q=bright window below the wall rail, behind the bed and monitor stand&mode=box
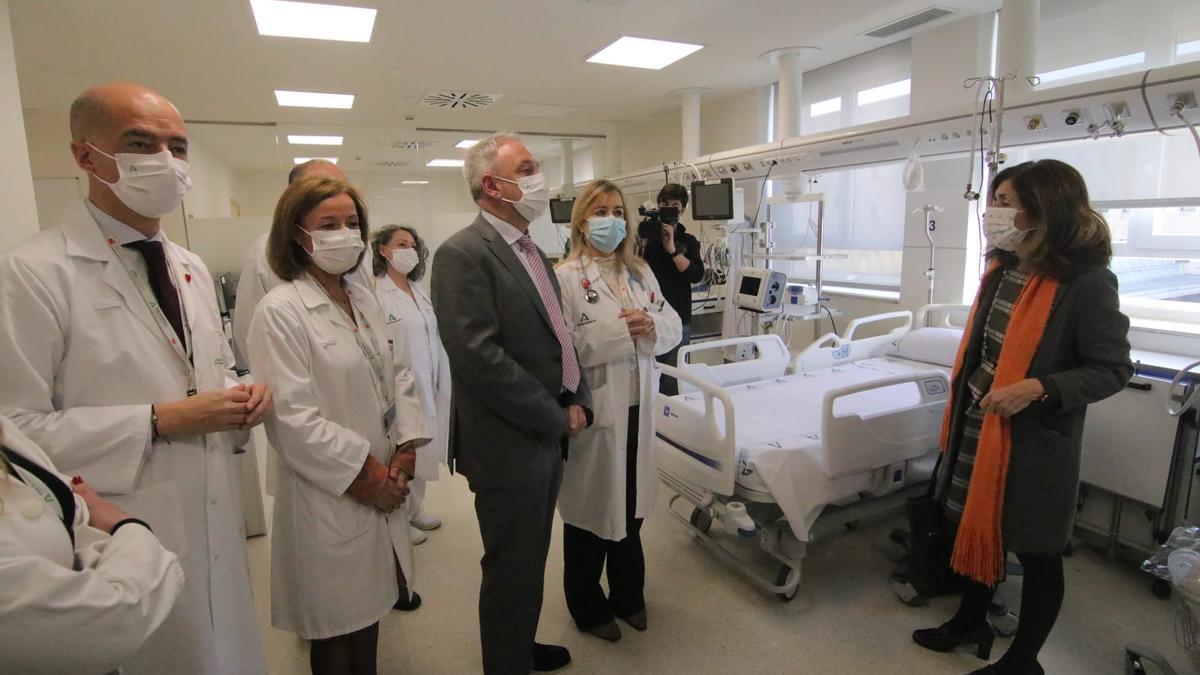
[769,163,907,292]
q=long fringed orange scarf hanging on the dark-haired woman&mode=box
[942,261,1058,586]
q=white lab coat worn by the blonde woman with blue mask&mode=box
[554,257,683,542]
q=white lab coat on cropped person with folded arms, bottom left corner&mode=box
[0,417,184,674]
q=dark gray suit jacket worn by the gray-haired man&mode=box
[431,215,592,488]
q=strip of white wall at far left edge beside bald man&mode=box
[0,0,37,251]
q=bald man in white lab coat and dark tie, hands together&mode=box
[0,84,271,674]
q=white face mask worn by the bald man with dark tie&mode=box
[88,143,192,217]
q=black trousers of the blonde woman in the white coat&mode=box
[563,406,646,631]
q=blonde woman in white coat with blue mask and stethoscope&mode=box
[554,180,683,640]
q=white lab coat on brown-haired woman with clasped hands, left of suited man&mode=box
[250,275,428,639]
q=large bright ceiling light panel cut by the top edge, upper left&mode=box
[250,0,376,42]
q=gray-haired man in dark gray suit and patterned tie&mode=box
[432,133,592,675]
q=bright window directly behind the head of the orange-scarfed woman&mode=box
[1009,133,1200,323]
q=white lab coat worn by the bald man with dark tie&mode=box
[0,201,266,675]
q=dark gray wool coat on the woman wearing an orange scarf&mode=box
[937,263,1133,555]
